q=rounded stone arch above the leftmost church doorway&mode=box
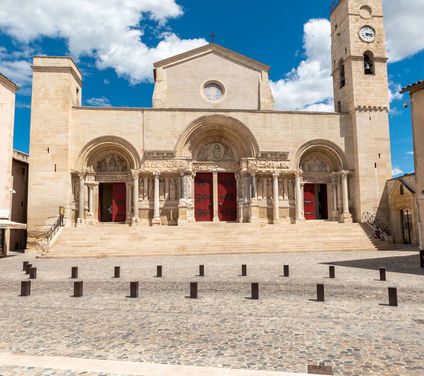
[76,136,141,172]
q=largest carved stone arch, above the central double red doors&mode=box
[175,115,259,161]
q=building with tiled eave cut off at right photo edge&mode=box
[402,81,424,250]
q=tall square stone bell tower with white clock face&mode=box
[331,0,392,223]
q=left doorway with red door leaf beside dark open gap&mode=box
[99,183,127,223]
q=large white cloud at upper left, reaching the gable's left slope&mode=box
[0,0,206,83]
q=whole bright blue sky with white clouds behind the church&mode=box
[0,0,424,173]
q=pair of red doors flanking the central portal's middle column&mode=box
[194,173,237,222]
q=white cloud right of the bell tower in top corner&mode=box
[383,0,424,63]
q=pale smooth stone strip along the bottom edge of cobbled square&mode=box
[0,352,307,376]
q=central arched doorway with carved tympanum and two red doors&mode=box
[176,115,258,222]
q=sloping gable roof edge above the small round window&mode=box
[153,43,271,72]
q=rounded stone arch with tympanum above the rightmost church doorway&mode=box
[296,140,348,173]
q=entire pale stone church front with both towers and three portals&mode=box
[28,0,391,238]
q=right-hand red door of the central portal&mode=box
[218,174,237,222]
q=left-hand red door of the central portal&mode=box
[194,173,213,222]
